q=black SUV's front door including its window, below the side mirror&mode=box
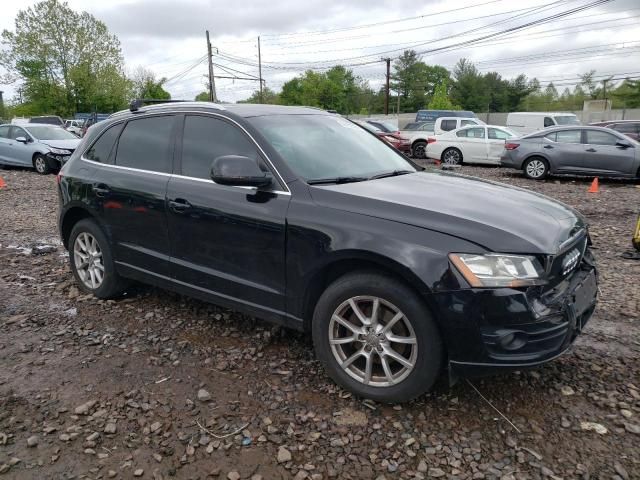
[167,114,290,316]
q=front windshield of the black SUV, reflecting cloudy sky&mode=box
[248,115,417,183]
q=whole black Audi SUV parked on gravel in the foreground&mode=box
[58,102,597,402]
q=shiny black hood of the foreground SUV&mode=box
[311,172,585,254]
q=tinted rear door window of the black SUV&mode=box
[116,116,174,173]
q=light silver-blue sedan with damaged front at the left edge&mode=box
[0,123,81,175]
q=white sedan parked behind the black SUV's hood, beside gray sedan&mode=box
[427,125,518,165]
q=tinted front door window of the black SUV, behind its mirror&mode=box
[182,115,258,179]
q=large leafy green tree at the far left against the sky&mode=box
[0,0,130,115]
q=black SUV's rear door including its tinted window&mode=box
[87,115,177,277]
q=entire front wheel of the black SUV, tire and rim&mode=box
[312,272,442,403]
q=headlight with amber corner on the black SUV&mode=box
[449,253,546,288]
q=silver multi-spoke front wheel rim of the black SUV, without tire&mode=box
[328,296,418,387]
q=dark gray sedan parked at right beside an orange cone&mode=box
[500,126,640,180]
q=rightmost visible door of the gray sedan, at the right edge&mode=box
[584,130,635,175]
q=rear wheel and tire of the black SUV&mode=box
[69,219,127,299]
